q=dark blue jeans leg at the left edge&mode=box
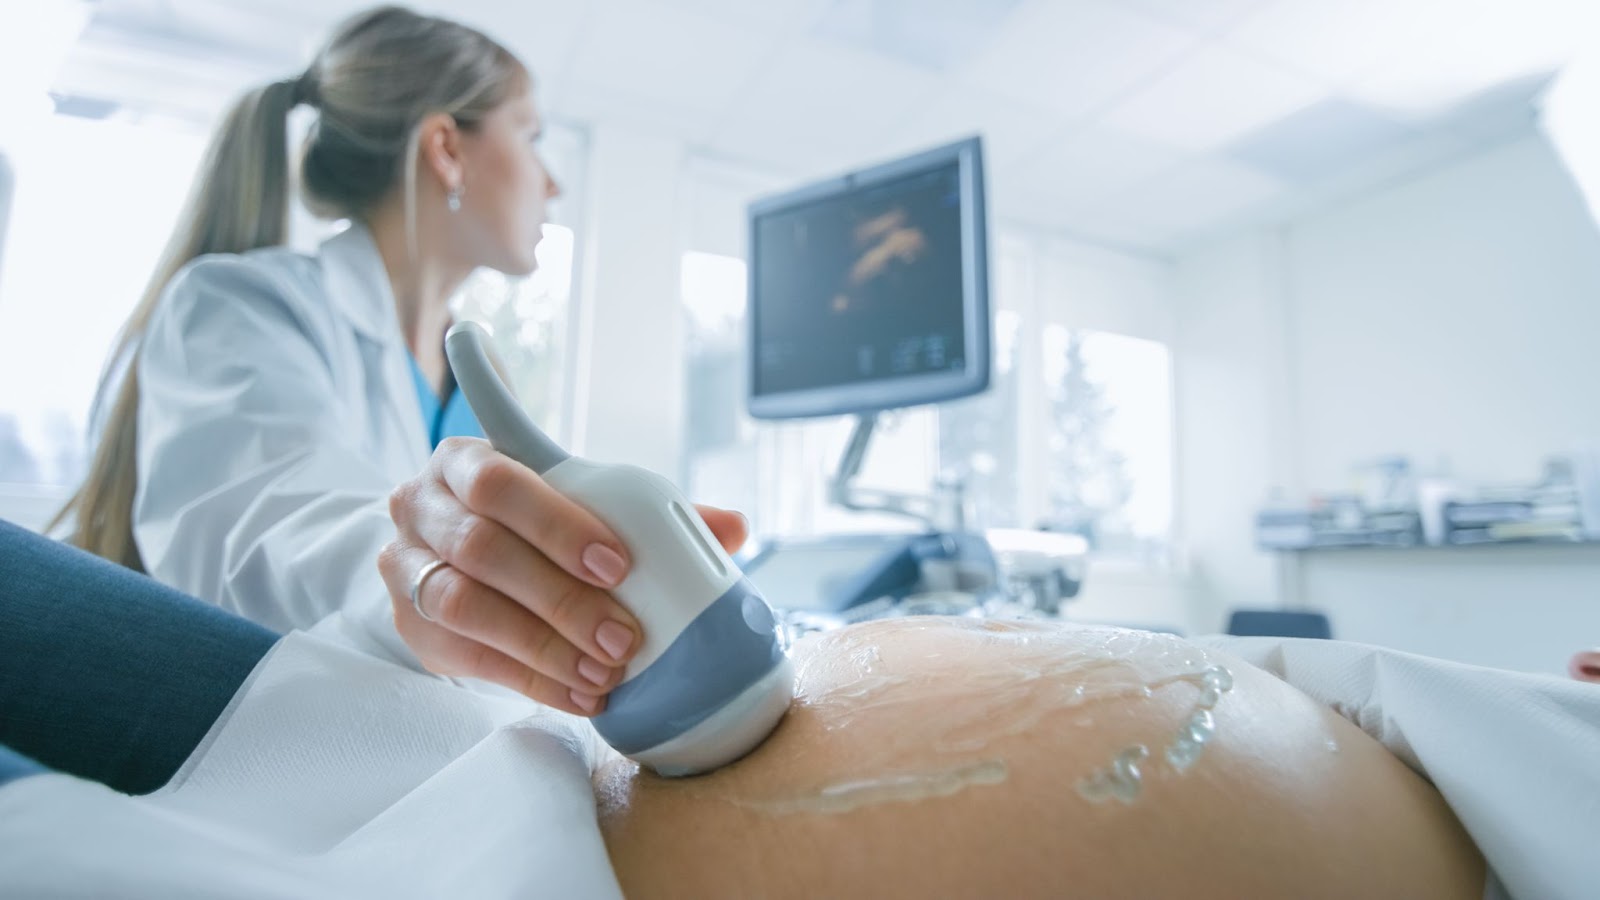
[0,520,278,794]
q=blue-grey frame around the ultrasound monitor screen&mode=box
[746,136,990,420]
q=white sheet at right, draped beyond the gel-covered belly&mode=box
[1197,636,1600,900]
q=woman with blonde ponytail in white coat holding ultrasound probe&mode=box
[62,6,744,714]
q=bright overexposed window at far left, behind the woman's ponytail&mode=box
[0,115,206,493]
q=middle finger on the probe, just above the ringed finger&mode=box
[402,482,640,666]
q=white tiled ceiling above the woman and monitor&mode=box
[43,0,1600,255]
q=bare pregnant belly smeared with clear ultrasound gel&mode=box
[595,618,1485,898]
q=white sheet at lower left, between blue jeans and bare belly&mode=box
[0,633,621,900]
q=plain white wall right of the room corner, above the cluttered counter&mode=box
[1290,138,1600,487]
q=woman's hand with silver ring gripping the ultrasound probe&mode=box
[378,437,747,716]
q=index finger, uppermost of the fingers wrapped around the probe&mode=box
[432,439,629,588]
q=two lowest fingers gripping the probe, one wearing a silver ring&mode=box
[378,543,622,714]
